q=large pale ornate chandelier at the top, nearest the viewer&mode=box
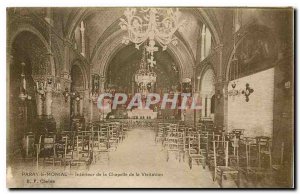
[119,8,185,60]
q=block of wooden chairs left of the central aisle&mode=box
[24,122,129,168]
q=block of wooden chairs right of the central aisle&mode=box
[155,123,283,187]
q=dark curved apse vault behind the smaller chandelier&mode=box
[106,44,180,88]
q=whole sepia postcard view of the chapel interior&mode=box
[7,7,294,188]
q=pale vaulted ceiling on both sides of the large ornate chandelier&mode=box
[61,8,218,61]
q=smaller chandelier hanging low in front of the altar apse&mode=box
[134,49,157,95]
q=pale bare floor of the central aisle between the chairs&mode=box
[60,128,218,188]
